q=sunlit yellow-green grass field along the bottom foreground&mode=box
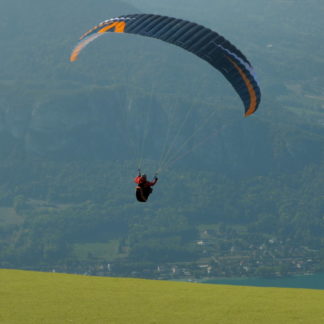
[0,269,324,324]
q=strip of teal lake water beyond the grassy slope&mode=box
[204,273,324,289]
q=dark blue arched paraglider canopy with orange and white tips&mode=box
[70,14,261,116]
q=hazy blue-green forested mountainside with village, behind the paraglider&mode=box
[0,0,324,278]
